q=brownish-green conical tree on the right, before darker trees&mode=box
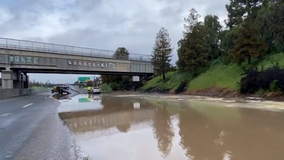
[230,19,267,64]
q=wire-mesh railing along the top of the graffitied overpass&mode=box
[0,37,151,62]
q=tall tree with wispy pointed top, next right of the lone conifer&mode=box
[176,9,209,76]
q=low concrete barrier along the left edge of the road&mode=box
[0,88,48,99]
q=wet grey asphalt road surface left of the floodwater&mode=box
[0,93,78,160]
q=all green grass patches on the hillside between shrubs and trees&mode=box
[142,53,284,90]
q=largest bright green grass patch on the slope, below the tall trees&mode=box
[188,64,243,89]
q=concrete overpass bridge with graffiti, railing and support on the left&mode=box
[0,38,153,89]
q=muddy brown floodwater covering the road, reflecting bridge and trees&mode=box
[58,95,284,160]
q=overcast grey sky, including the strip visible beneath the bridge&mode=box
[0,0,229,83]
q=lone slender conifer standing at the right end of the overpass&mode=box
[151,27,172,80]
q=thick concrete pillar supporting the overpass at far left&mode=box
[1,70,19,89]
